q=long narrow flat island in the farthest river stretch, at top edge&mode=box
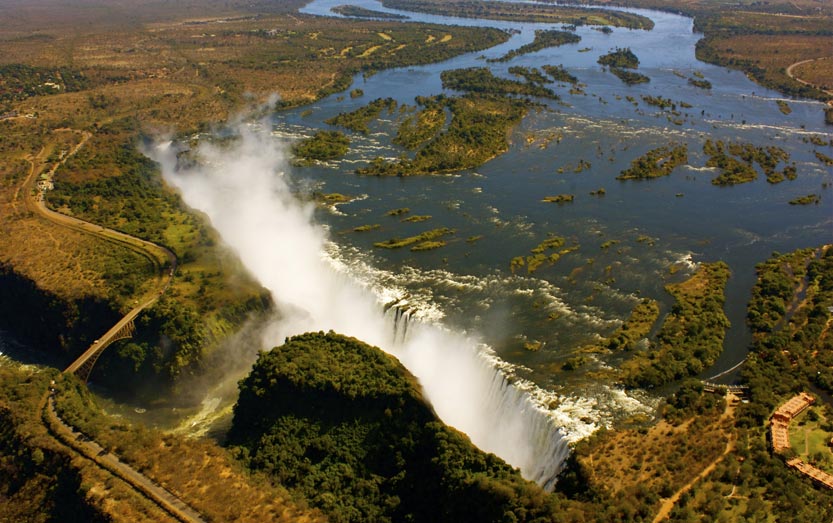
[382,0,654,29]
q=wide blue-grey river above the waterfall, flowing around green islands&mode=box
[30,0,833,450]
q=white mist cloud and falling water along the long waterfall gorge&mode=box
[150,121,569,488]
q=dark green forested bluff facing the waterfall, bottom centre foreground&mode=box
[228,332,558,522]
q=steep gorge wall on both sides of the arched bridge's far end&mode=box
[0,263,272,399]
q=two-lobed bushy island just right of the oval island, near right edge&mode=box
[703,139,797,185]
